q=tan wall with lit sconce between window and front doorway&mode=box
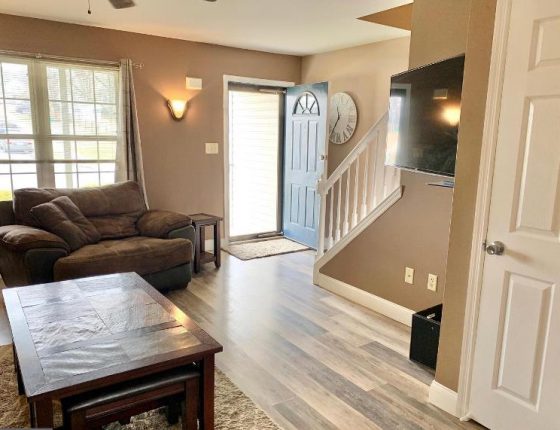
[0,15,301,215]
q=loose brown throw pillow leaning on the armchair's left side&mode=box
[31,196,101,251]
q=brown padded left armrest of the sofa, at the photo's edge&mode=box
[0,225,70,252]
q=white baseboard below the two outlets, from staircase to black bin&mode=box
[315,273,414,327]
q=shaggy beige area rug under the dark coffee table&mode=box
[0,346,278,430]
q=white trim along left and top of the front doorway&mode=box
[223,75,295,245]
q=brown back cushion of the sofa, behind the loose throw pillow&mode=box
[14,181,147,239]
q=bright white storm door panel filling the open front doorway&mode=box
[228,85,284,240]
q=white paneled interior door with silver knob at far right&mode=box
[470,0,560,430]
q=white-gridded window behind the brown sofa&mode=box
[0,57,124,200]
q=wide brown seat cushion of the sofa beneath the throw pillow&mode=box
[54,236,192,281]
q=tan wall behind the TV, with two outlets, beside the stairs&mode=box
[321,0,470,310]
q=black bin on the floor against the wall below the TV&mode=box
[409,305,443,370]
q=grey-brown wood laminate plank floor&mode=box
[0,251,481,430]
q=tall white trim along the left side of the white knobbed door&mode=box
[457,0,513,420]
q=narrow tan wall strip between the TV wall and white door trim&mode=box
[436,0,496,390]
